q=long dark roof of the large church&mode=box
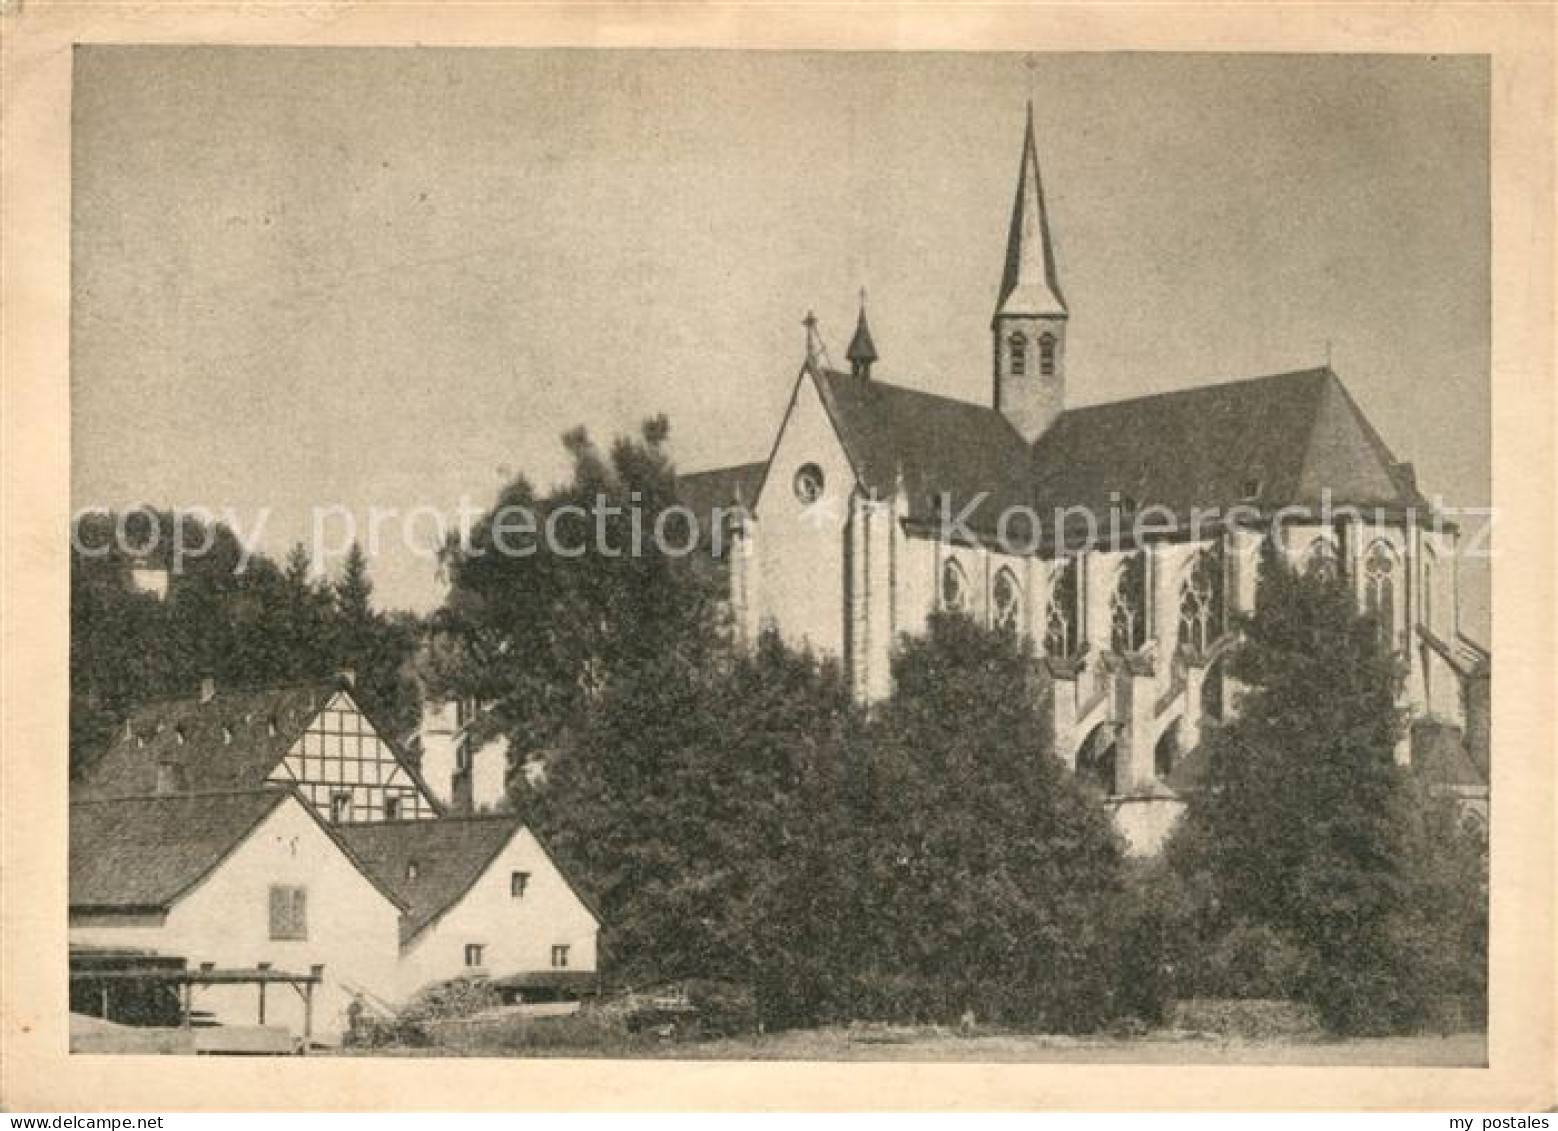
[701,368,1429,541]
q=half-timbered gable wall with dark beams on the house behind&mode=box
[270,690,438,824]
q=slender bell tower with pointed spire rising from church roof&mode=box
[991,101,1067,444]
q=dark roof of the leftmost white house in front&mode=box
[70,788,291,911]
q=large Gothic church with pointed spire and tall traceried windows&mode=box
[682,106,1489,854]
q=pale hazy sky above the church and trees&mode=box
[72,47,1491,639]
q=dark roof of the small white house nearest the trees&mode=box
[337,816,600,943]
